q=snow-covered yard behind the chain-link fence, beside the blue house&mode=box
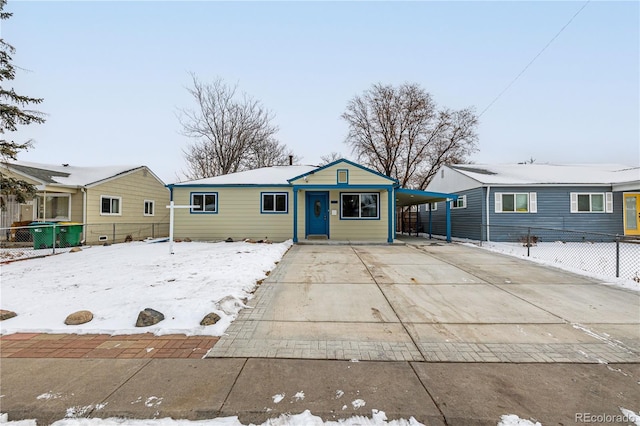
[474,241,640,291]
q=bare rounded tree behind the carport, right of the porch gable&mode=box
[342,83,478,189]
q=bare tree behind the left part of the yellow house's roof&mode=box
[178,74,291,179]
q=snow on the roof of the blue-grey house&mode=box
[450,164,640,185]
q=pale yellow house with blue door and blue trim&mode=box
[168,160,455,243]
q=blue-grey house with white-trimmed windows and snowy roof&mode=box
[421,164,640,241]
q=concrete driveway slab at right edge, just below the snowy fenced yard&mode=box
[498,284,640,324]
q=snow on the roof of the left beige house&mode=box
[7,161,144,186]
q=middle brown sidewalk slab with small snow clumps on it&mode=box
[221,359,444,425]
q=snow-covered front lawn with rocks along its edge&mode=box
[0,241,292,336]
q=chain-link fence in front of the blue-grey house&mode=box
[480,225,640,282]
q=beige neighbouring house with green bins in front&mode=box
[0,161,169,243]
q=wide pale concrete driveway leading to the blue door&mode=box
[208,240,640,363]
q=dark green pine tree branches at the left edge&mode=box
[0,0,45,203]
